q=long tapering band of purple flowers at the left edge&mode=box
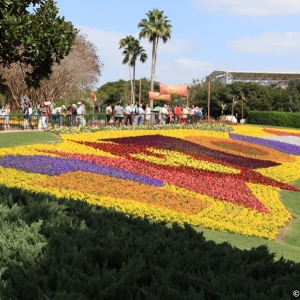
[0,155,164,186]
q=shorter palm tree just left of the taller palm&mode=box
[119,35,148,103]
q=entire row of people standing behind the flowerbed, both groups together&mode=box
[0,101,203,130]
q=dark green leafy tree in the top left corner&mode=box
[0,0,77,87]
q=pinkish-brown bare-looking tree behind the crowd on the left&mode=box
[0,34,103,108]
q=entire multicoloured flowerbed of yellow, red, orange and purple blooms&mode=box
[0,125,300,239]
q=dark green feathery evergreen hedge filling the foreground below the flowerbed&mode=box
[0,186,300,300]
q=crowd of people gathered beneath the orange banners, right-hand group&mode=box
[105,102,203,125]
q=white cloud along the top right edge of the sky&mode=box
[192,0,300,16]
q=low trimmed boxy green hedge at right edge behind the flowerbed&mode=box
[247,111,300,128]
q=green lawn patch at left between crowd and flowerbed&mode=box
[0,131,62,148]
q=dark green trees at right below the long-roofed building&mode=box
[189,80,300,119]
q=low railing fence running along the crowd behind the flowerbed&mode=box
[0,112,202,130]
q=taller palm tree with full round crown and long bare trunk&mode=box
[138,8,172,108]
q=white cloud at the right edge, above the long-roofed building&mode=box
[226,32,300,53]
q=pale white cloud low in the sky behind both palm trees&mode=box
[75,26,199,84]
